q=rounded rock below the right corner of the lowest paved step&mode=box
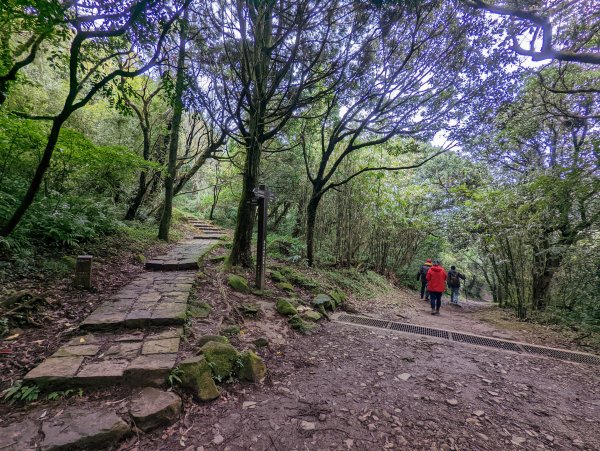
[129,387,181,432]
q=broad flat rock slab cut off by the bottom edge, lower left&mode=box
[41,408,131,451]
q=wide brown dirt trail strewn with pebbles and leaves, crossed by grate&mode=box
[131,284,600,451]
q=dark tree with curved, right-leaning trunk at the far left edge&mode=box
[0,0,185,236]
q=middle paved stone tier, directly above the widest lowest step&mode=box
[80,271,196,330]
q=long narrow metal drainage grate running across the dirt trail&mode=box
[337,313,600,365]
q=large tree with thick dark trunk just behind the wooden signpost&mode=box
[199,0,348,266]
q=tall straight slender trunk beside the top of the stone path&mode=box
[158,15,188,241]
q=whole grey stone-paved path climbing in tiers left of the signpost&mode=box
[25,231,217,389]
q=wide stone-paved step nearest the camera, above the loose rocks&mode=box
[24,327,183,390]
